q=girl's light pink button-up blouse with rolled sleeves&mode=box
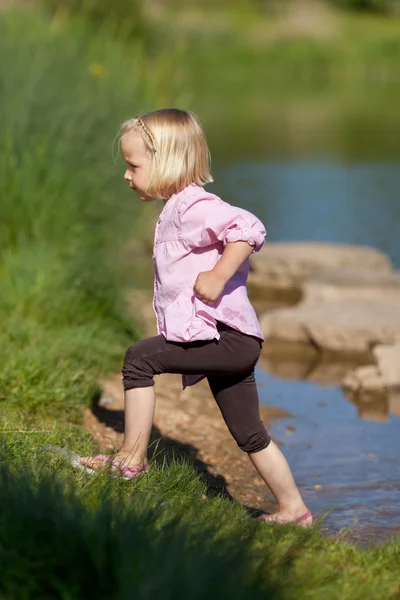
[153,185,266,389]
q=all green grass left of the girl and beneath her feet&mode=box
[0,5,400,600]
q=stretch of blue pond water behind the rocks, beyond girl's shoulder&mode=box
[216,161,400,268]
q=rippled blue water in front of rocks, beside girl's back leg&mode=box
[257,361,400,544]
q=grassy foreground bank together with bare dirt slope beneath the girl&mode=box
[0,290,400,600]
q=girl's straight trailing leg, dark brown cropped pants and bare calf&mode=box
[208,370,312,525]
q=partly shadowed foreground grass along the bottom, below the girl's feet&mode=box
[0,431,400,600]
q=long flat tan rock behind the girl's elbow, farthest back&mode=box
[248,242,392,290]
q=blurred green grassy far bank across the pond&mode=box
[141,2,400,162]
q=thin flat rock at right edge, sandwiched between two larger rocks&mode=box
[302,267,400,304]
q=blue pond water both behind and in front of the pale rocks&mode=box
[209,107,400,544]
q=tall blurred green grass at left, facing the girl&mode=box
[0,12,167,421]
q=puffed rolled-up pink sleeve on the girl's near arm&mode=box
[180,198,266,253]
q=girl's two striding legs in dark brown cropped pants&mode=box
[81,330,310,510]
